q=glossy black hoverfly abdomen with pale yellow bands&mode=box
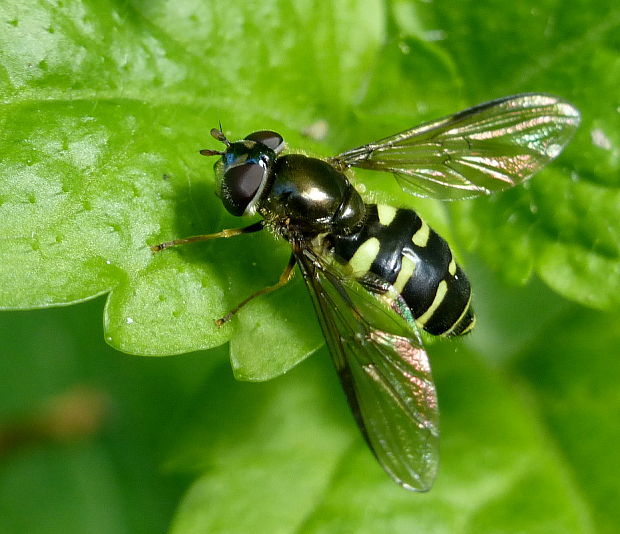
[329,204,475,336]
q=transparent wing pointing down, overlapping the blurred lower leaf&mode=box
[297,245,439,491]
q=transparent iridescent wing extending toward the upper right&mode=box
[330,93,580,200]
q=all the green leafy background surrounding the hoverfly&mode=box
[0,0,620,534]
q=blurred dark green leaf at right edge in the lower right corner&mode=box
[514,310,620,532]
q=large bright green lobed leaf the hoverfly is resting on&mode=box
[0,0,620,368]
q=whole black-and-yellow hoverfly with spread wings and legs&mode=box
[152,93,579,491]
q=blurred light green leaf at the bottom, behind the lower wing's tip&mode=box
[172,344,589,534]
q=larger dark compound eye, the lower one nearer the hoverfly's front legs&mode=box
[221,163,267,217]
